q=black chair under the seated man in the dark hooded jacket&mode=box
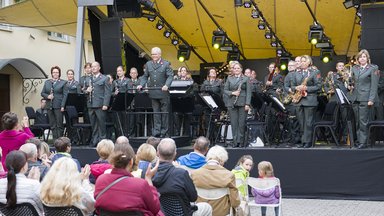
[160,193,192,216]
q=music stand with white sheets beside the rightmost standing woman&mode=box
[336,88,356,148]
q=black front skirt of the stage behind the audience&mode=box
[72,142,384,201]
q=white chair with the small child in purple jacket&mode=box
[247,177,282,216]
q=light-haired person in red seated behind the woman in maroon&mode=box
[89,139,115,184]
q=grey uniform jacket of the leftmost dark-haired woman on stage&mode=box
[41,79,67,109]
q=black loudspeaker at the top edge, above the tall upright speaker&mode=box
[108,0,142,18]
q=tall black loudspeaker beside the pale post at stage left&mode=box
[100,18,122,74]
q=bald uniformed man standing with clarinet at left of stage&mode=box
[86,62,112,146]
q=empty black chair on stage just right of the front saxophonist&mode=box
[312,101,340,146]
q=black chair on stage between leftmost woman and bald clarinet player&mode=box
[65,106,92,145]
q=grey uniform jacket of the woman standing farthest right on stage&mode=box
[352,64,380,102]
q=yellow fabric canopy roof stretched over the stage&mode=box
[0,0,360,70]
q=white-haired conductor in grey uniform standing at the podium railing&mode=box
[137,47,173,137]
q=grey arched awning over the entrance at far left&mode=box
[0,58,48,79]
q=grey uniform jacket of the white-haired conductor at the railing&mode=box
[140,59,173,99]
